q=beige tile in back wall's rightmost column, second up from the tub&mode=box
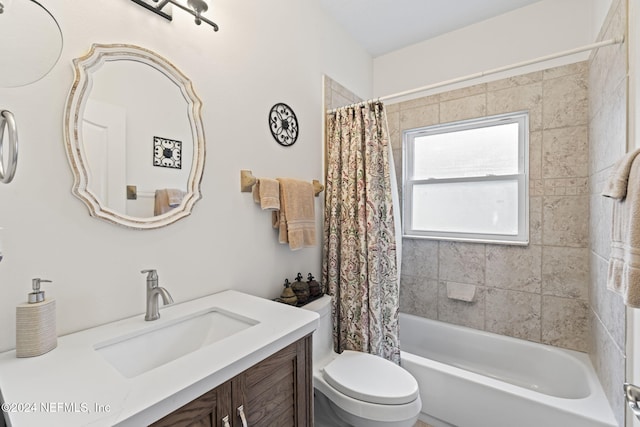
[542,246,589,300]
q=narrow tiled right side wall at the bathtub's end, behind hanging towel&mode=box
[589,0,627,426]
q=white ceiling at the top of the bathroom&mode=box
[320,0,540,57]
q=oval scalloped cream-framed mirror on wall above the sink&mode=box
[62,44,205,228]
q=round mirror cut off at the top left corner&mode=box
[0,0,62,87]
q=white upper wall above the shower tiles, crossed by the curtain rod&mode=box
[373,0,611,102]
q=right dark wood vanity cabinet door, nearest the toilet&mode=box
[232,336,313,427]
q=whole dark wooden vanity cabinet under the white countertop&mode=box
[151,335,313,427]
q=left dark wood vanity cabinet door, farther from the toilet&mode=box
[151,381,233,427]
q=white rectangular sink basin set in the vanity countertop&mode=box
[94,308,259,378]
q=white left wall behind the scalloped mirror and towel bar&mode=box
[0,0,373,350]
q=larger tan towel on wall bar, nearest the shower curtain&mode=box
[272,178,316,251]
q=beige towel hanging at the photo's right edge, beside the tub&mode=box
[603,151,640,308]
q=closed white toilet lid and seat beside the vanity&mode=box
[323,350,418,405]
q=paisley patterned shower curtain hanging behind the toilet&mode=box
[322,102,400,363]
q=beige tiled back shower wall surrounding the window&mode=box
[387,62,589,351]
